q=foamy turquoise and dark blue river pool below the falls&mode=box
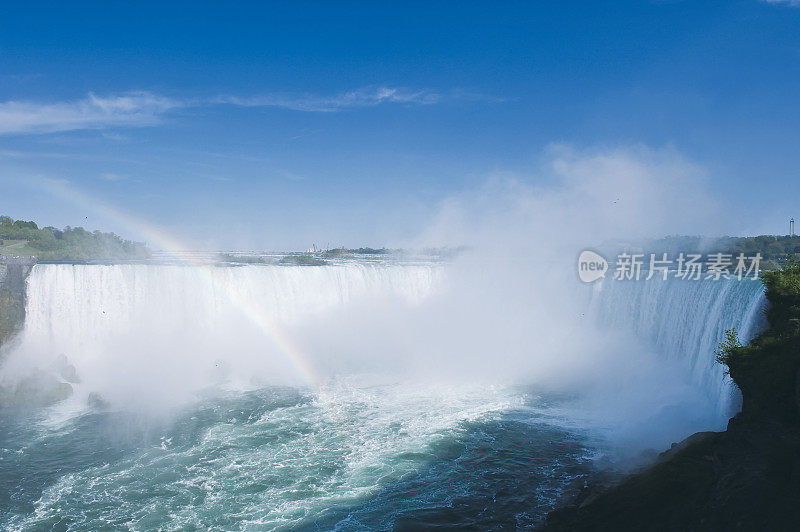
[0,385,594,530]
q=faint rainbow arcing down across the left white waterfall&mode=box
[32,179,323,395]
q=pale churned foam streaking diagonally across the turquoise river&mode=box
[11,381,523,529]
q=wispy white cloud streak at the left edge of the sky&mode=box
[0,92,182,134]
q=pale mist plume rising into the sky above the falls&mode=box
[410,145,723,255]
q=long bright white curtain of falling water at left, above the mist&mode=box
[25,263,442,338]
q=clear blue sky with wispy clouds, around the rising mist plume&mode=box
[0,0,800,249]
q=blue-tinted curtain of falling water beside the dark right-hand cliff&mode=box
[592,279,765,422]
